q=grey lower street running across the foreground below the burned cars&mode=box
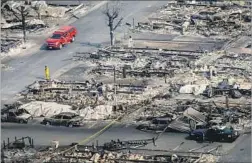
[1,123,251,163]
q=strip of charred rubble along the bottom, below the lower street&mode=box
[1,137,218,163]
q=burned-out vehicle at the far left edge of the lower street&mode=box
[1,109,32,123]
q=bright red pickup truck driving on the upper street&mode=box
[46,26,77,49]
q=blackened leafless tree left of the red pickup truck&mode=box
[11,6,29,42]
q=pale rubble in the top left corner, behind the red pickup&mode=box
[1,1,88,36]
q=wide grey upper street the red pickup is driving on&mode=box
[1,1,166,103]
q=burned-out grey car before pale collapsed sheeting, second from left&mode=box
[41,112,83,127]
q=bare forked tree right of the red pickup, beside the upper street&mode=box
[103,3,123,46]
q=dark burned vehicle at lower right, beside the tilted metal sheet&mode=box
[189,126,240,142]
